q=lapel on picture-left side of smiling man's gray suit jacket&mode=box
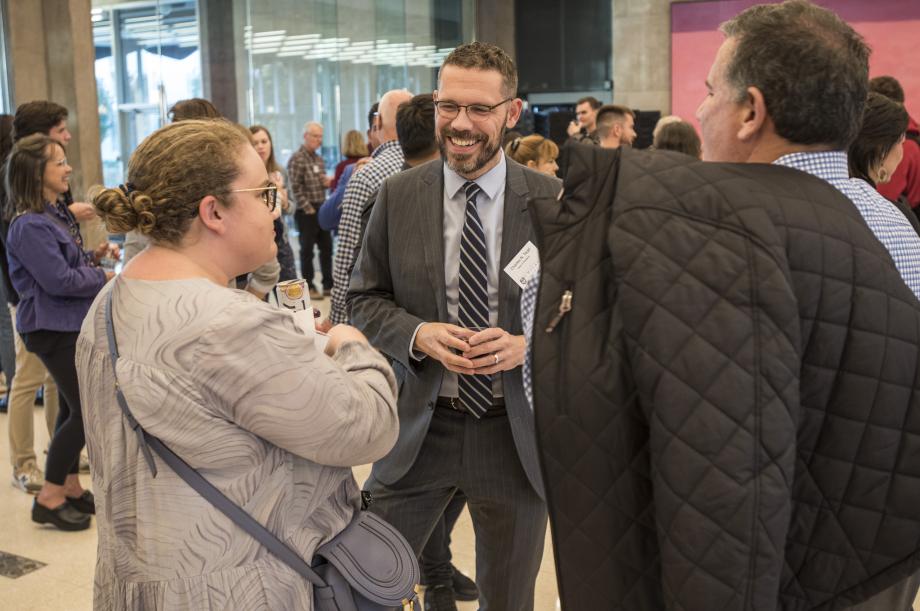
[418,162,447,322]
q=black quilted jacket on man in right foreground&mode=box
[532,147,920,611]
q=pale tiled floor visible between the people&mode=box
[0,286,558,611]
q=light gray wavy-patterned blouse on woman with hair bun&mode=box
[77,278,399,610]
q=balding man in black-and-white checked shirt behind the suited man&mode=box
[329,89,412,325]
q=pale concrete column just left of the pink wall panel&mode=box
[612,0,671,114]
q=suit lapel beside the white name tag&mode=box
[498,159,531,333]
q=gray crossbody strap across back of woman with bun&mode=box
[105,286,326,588]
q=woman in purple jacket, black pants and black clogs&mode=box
[5,134,113,530]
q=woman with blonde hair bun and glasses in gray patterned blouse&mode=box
[85,121,398,610]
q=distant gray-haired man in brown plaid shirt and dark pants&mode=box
[288,121,332,299]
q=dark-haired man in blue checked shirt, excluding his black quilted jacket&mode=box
[697,2,920,611]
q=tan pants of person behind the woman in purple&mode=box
[7,306,58,470]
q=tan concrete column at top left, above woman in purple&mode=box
[7,0,105,245]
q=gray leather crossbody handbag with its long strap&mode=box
[105,287,419,611]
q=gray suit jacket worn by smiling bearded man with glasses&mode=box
[347,159,562,498]
